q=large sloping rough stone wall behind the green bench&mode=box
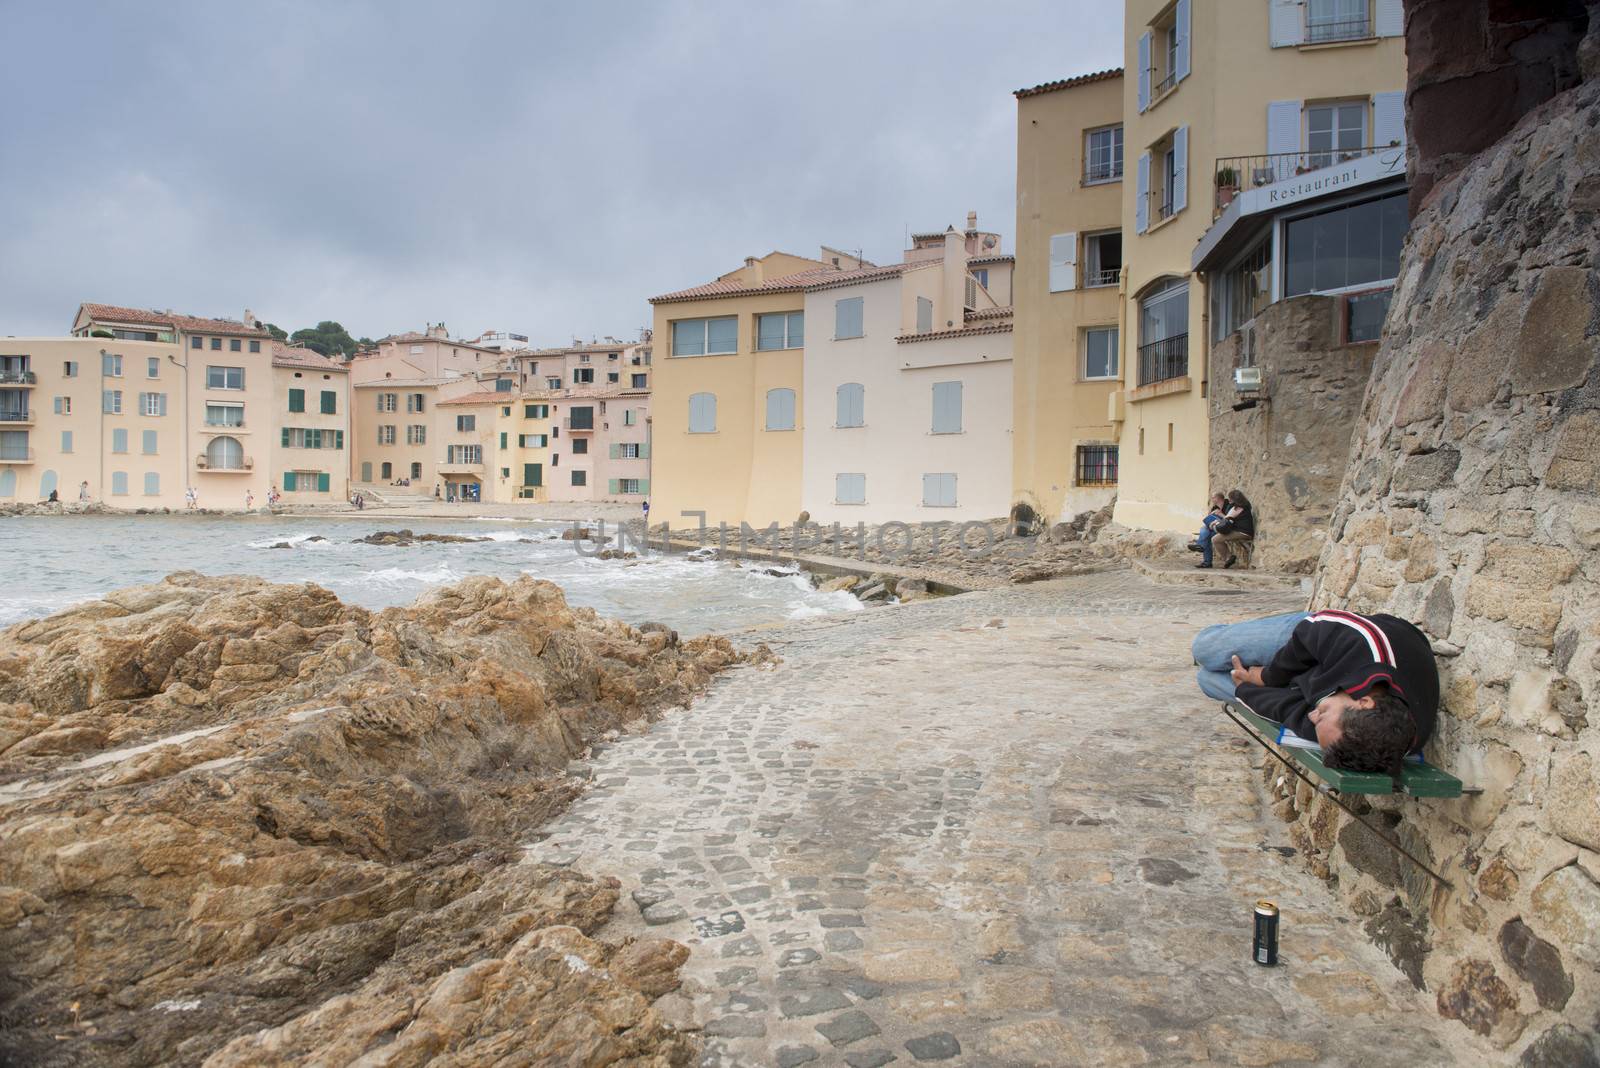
[1280,3,1600,1065]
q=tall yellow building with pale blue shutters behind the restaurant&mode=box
[1107,0,1405,531]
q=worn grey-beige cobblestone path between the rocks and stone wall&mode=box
[530,571,1454,1068]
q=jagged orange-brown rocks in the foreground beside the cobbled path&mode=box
[0,572,760,1065]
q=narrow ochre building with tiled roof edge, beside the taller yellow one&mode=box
[1011,70,1123,521]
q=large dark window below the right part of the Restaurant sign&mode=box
[1283,193,1406,297]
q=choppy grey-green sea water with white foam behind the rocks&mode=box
[0,515,861,635]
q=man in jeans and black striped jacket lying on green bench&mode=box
[1192,609,1438,775]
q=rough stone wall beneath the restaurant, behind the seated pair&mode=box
[1206,296,1378,574]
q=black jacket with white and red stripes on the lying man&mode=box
[1237,609,1438,753]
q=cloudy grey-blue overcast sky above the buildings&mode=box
[0,0,1122,344]
